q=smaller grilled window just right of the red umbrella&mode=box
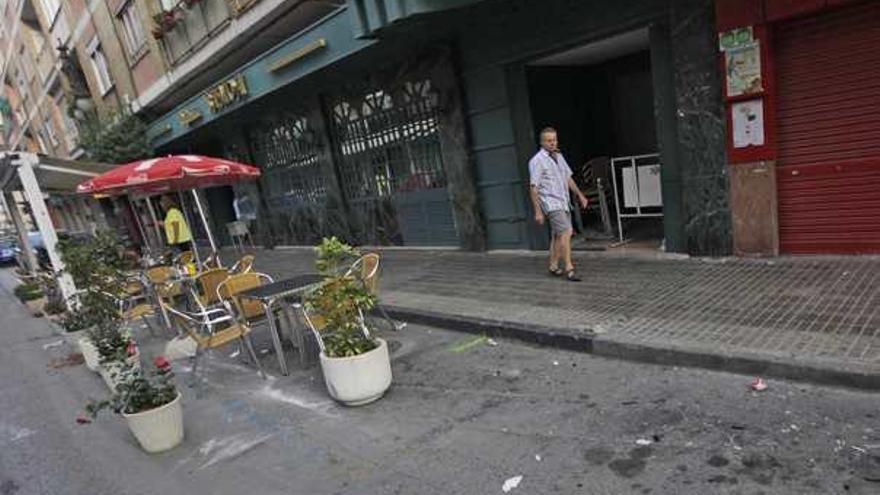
[251,114,327,209]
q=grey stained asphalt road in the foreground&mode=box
[0,272,880,495]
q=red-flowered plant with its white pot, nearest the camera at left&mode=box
[86,356,183,454]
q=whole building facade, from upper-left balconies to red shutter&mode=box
[0,0,880,255]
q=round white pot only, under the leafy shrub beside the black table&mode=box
[321,339,391,406]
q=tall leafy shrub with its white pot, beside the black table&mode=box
[305,237,392,406]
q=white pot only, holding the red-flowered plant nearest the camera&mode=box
[122,392,183,454]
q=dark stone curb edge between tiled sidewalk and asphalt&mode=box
[382,305,880,391]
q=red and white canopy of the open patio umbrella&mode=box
[76,155,260,194]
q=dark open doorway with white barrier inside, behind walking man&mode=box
[526,29,663,250]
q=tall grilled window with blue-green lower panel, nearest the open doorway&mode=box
[331,79,458,245]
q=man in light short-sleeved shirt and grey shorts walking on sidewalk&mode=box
[529,127,589,282]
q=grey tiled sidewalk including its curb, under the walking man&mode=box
[244,249,880,389]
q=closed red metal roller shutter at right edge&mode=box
[775,1,880,254]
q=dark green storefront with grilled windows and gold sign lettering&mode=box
[151,0,730,254]
